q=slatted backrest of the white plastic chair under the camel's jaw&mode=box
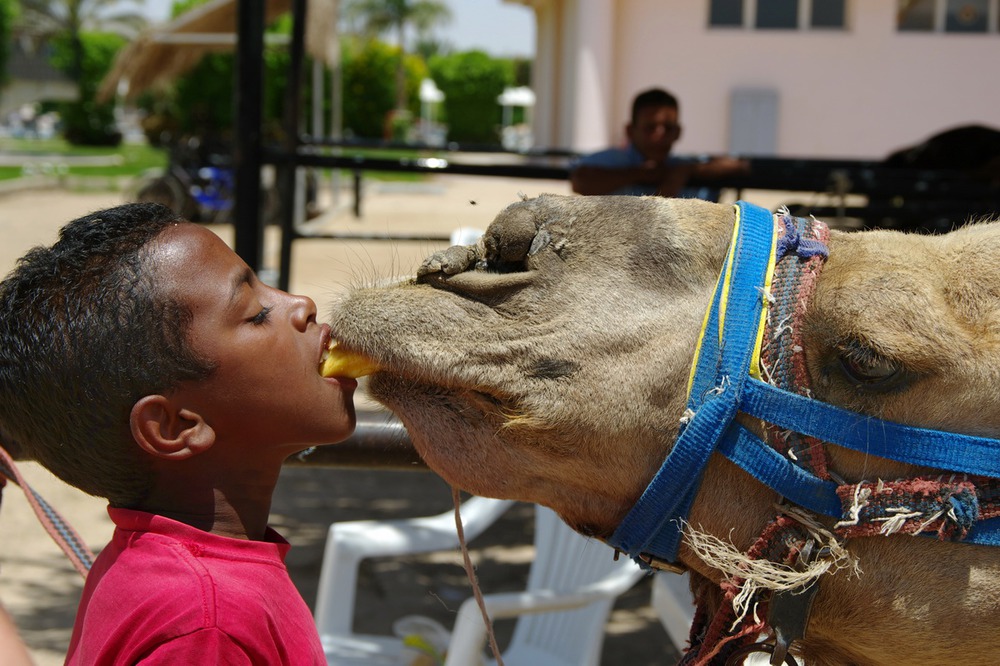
[503,505,644,666]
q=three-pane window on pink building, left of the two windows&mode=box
[708,0,845,30]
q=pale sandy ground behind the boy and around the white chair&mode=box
[0,176,712,666]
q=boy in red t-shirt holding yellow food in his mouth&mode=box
[0,204,357,666]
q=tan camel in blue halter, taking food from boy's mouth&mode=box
[331,195,1000,665]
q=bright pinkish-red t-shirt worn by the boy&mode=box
[66,508,326,666]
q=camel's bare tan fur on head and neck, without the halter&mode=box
[331,196,1000,663]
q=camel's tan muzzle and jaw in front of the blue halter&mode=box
[331,197,732,534]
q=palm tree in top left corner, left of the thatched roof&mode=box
[20,0,146,80]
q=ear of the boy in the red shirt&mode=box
[129,395,215,460]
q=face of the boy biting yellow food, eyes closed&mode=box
[154,224,357,453]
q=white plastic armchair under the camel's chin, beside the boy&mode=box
[316,497,643,666]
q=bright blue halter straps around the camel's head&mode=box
[608,201,1000,566]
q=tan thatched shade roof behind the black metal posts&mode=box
[98,0,338,100]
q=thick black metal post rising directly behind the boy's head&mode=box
[233,0,264,271]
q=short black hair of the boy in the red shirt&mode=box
[0,204,218,507]
